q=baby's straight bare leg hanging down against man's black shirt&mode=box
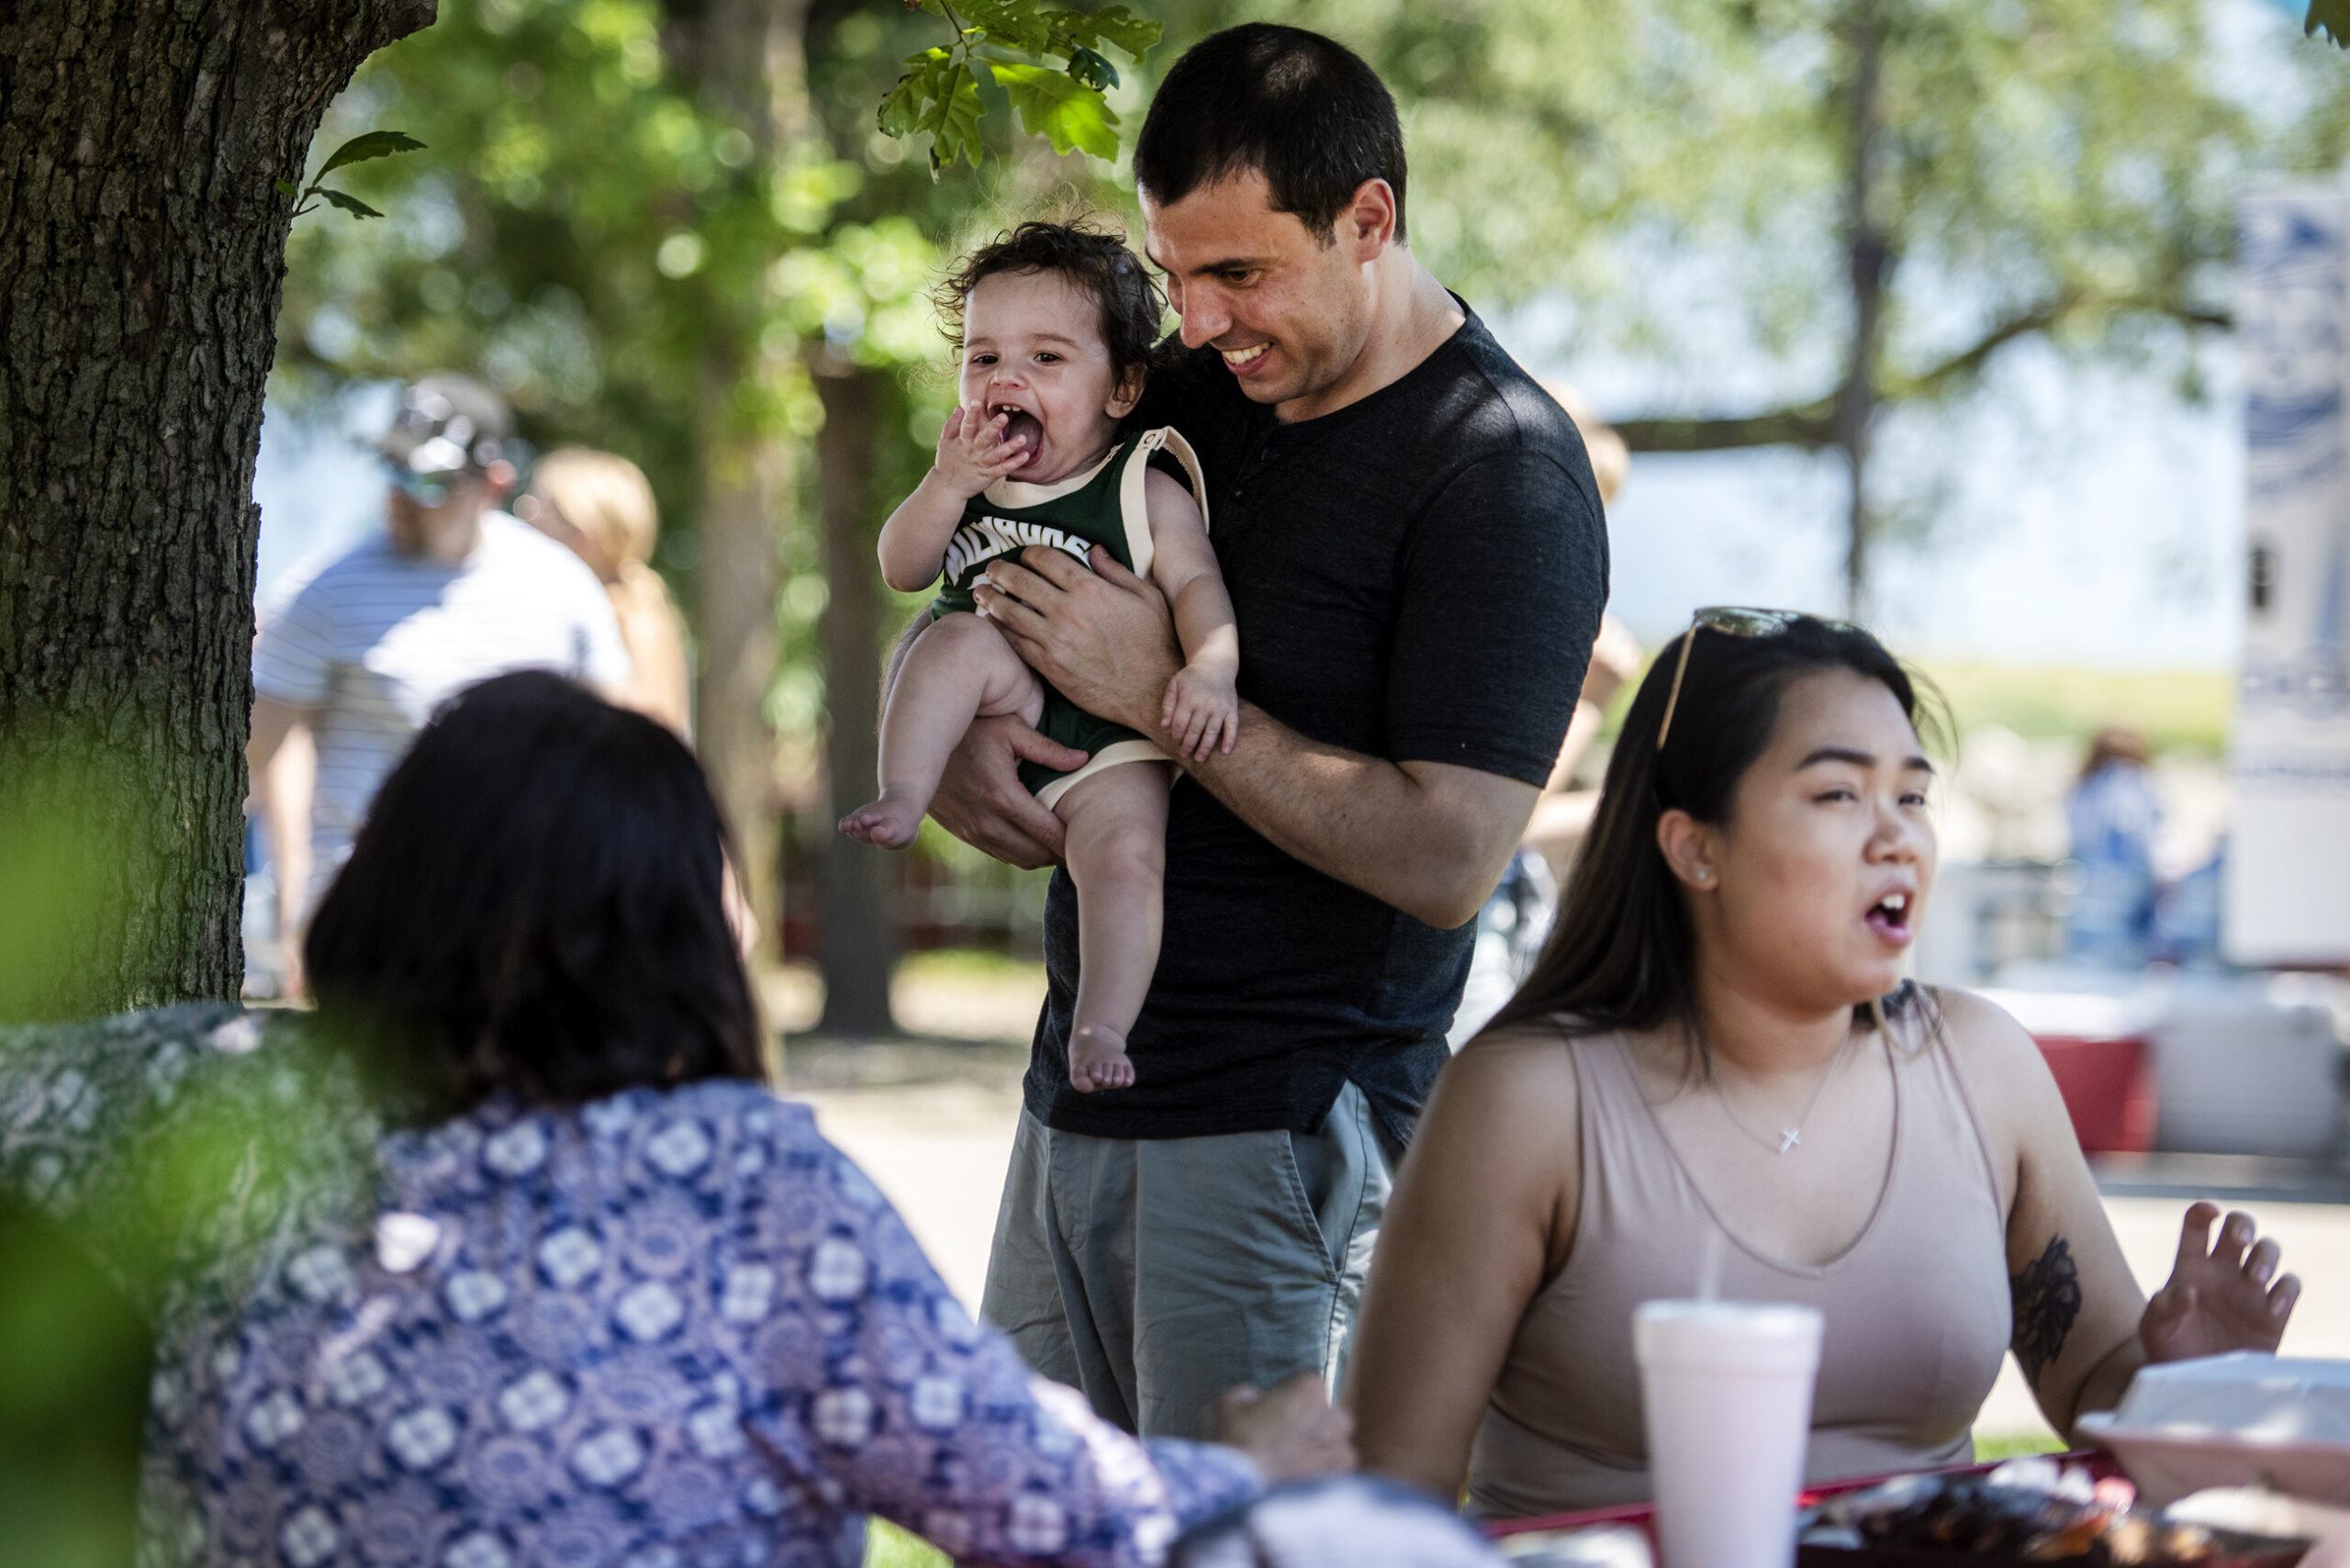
[1058,762,1168,1093]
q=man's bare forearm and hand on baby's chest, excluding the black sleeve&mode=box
[977,548,1537,928]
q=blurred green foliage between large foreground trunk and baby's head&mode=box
[273,0,1135,790]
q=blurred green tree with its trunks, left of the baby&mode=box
[277,0,1165,1036]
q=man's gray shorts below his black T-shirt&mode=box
[982,1083,1401,1437]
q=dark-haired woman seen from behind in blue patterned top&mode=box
[0,675,1348,1568]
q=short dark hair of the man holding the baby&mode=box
[1135,21,1403,244]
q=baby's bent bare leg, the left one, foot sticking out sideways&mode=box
[841,613,1044,848]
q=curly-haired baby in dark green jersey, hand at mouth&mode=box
[841,223,1241,1093]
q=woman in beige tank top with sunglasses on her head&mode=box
[1347,611,2300,1517]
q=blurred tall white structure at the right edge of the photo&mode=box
[2221,188,2350,964]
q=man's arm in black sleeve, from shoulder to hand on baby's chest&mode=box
[978,434,1607,928]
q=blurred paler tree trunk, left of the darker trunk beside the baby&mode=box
[663,0,809,958]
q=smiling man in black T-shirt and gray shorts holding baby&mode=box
[907,24,1607,1437]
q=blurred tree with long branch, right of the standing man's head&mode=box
[1249,0,2343,611]
